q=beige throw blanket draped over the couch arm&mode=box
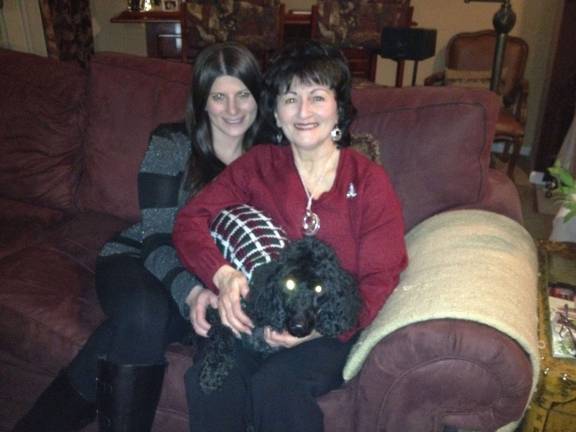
[344,210,539,432]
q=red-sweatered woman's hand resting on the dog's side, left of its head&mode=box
[213,265,254,336]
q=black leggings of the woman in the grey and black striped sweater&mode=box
[68,255,191,401]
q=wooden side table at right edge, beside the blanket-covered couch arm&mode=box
[522,241,576,432]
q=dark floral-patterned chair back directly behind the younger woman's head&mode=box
[180,0,284,66]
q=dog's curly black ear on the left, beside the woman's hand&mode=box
[245,261,286,330]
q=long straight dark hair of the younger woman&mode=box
[185,42,262,196]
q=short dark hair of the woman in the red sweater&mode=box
[259,40,356,147]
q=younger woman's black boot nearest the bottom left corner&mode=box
[12,370,96,432]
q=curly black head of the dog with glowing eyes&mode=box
[247,237,361,337]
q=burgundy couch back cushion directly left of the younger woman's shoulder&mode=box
[78,53,191,221]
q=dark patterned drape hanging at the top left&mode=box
[39,0,94,65]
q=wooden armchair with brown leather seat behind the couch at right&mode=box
[424,30,529,178]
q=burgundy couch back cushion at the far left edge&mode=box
[0,49,86,210]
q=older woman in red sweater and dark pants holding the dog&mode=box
[173,41,406,432]
